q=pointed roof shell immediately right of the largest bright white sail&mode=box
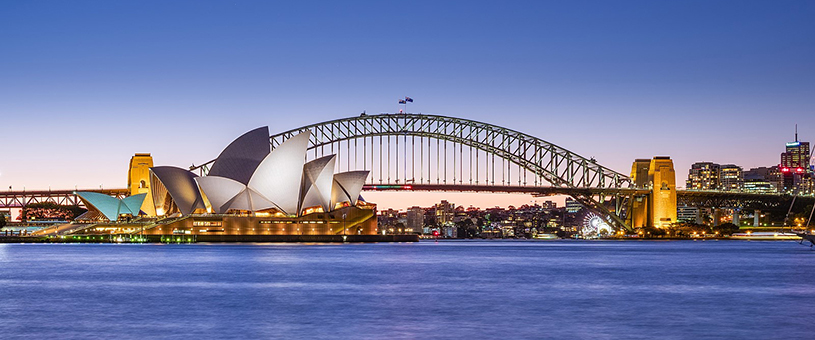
[298,155,337,212]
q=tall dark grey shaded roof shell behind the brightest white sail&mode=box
[208,126,270,184]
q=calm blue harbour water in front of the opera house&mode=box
[0,241,815,339]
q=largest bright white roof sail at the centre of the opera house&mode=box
[249,131,311,215]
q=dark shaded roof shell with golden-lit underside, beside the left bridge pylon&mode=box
[150,166,206,215]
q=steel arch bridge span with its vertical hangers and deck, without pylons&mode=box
[191,114,641,227]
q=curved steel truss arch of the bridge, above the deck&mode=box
[270,114,631,188]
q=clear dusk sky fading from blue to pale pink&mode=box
[0,1,815,208]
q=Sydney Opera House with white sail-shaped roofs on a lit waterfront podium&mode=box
[60,127,386,241]
